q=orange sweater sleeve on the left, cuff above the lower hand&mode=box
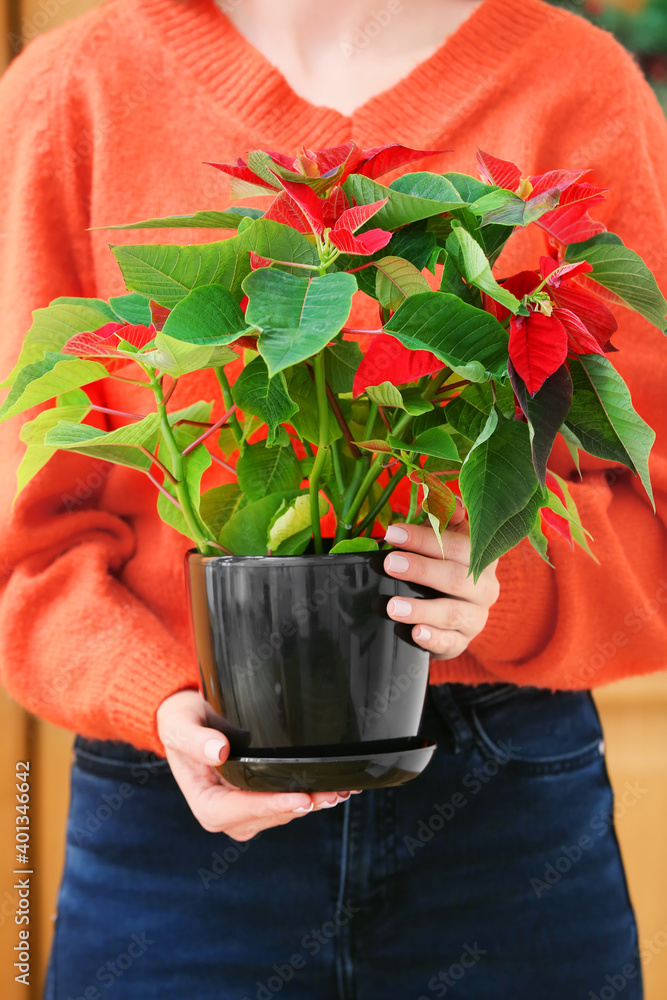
[0,39,197,753]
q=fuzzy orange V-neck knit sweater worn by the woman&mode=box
[0,0,667,752]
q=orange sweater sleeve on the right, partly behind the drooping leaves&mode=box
[434,50,667,688]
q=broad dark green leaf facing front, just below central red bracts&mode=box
[243,272,357,376]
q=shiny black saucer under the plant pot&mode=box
[219,736,436,792]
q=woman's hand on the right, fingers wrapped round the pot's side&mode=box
[384,503,500,660]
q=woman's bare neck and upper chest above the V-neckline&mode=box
[217,0,480,115]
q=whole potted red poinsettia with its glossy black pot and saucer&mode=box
[0,142,667,790]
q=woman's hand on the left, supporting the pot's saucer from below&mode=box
[157,691,350,840]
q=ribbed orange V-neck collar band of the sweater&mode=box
[135,0,551,149]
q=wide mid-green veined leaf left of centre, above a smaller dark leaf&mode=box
[111,233,250,309]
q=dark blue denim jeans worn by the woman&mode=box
[45,684,642,1000]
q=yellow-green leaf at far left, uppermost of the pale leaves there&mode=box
[0,298,118,388]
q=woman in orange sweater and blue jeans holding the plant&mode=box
[0,0,667,1000]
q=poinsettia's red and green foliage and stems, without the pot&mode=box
[0,142,667,577]
